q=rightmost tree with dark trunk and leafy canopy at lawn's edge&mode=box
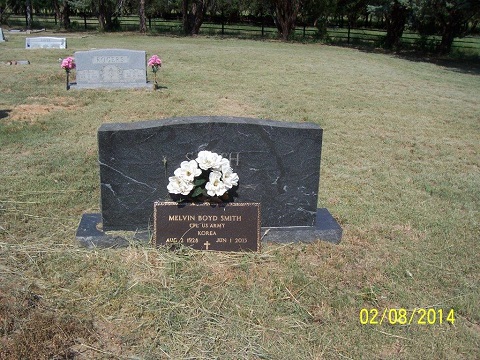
[415,0,480,54]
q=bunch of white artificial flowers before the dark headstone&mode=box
[167,150,239,203]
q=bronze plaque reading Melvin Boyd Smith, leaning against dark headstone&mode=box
[153,202,261,251]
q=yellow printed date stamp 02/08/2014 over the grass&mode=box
[359,308,455,325]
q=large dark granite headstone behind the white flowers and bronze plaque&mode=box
[77,117,342,243]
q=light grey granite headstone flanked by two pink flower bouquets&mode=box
[71,49,152,89]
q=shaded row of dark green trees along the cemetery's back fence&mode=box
[0,0,480,54]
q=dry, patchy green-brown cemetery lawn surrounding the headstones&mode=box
[0,33,480,359]
